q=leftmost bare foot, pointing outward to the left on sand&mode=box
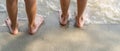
[5,18,18,35]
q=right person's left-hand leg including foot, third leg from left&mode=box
[60,0,70,25]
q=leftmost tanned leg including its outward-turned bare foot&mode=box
[6,0,18,34]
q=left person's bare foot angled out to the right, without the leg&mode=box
[29,16,44,35]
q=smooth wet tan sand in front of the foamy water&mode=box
[0,14,120,51]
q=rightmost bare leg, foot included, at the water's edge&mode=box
[76,0,87,27]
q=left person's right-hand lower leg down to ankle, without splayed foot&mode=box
[25,0,36,29]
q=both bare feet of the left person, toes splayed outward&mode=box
[5,16,44,35]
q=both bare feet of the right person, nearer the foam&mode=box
[60,14,84,28]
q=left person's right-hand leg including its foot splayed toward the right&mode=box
[25,0,43,34]
